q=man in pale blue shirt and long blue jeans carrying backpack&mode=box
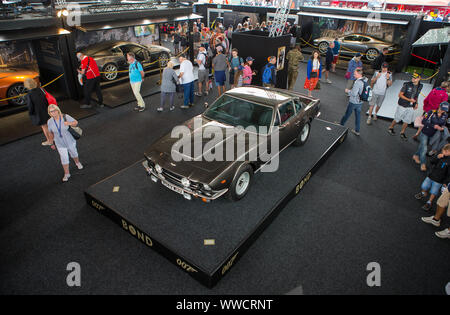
[340,69,368,136]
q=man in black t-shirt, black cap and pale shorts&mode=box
[388,73,423,141]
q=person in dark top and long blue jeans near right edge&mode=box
[413,103,449,171]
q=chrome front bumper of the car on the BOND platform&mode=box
[142,161,228,202]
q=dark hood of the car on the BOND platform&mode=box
[145,115,262,183]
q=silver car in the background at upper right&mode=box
[314,34,396,61]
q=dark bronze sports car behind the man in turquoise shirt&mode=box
[81,41,171,81]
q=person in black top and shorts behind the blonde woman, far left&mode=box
[23,78,52,146]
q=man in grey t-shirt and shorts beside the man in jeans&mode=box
[367,62,392,125]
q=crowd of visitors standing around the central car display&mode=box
[25,17,450,238]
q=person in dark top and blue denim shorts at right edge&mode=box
[414,144,450,211]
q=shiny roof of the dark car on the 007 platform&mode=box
[225,86,298,107]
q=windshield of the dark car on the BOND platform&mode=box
[203,95,273,133]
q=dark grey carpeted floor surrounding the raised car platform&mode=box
[0,65,450,294]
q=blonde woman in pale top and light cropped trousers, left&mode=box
[47,104,83,182]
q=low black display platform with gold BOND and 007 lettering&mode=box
[85,119,347,287]
